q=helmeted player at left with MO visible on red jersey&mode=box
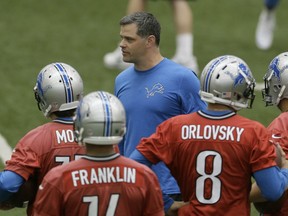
[0,63,85,215]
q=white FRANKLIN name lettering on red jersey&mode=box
[71,167,136,187]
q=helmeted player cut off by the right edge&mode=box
[253,52,288,216]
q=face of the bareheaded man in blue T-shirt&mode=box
[120,23,147,65]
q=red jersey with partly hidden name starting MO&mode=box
[5,120,85,215]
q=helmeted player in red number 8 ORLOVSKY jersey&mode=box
[131,55,288,215]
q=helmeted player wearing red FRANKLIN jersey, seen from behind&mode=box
[34,91,164,216]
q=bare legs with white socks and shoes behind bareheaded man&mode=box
[104,0,199,73]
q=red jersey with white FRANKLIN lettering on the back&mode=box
[34,153,164,216]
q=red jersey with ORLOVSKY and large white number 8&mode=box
[137,111,276,215]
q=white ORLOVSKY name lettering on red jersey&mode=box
[181,125,244,142]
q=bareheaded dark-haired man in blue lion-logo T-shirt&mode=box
[114,12,206,213]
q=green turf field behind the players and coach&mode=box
[0,0,288,216]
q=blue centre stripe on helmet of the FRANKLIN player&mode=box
[99,91,112,136]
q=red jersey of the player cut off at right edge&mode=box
[264,112,288,216]
